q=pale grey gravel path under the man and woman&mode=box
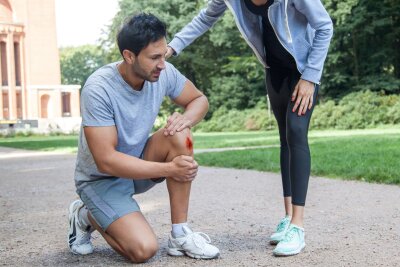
[0,148,400,266]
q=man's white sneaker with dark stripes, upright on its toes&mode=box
[68,199,93,255]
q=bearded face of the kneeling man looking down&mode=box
[132,38,167,82]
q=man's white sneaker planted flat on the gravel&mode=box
[168,226,219,259]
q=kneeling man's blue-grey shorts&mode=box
[78,149,165,231]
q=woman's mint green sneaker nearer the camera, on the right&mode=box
[273,224,306,256]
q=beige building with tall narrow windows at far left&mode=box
[0,0,80,131]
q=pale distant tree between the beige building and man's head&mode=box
[60,45,106,87]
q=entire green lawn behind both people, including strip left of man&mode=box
[0,126,400,184]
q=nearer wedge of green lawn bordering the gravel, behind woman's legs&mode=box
[196,133,400,184]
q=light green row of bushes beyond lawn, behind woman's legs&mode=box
[195,91,400,132]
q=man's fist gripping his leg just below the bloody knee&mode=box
[170,155,199,183]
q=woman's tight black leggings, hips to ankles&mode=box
[266,69,318,206]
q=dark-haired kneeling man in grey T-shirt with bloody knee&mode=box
[68,13,219,262]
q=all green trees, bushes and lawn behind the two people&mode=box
[0,0,400,185]
